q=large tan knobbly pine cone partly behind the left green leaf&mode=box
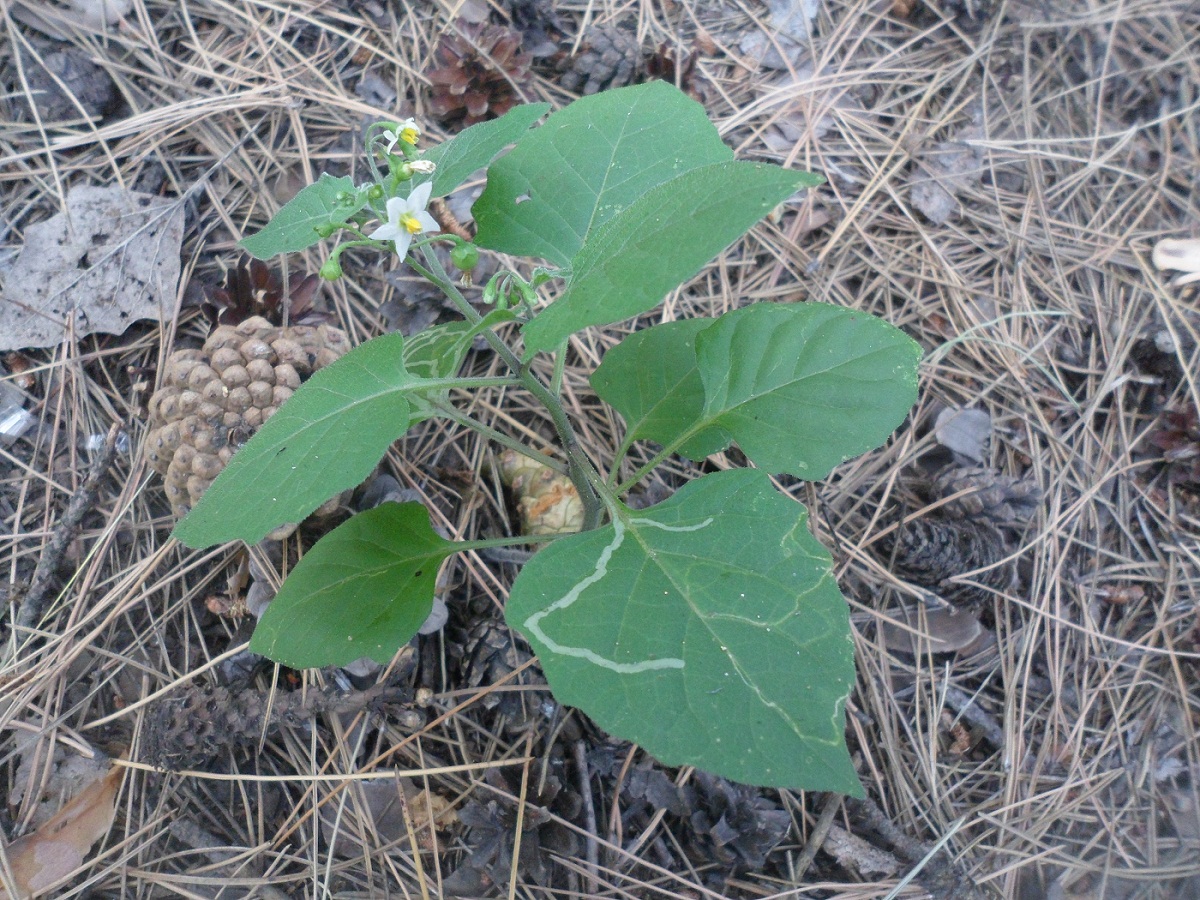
[146,263,350,540]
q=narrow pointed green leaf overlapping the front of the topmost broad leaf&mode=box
[524,162,820,355]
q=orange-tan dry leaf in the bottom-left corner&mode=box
[0,766,125,900]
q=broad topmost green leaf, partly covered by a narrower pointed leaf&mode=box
[473,82,733,266]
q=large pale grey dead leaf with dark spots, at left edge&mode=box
[0,185,184,350]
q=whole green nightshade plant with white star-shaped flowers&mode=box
[175,82,920,794]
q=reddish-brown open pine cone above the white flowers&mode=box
[425,25,532,127]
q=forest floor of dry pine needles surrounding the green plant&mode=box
[0,0,1200,900]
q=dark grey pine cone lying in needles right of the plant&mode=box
[878,516,1016,604]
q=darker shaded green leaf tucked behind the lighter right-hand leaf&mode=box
[592,319,726,460]
